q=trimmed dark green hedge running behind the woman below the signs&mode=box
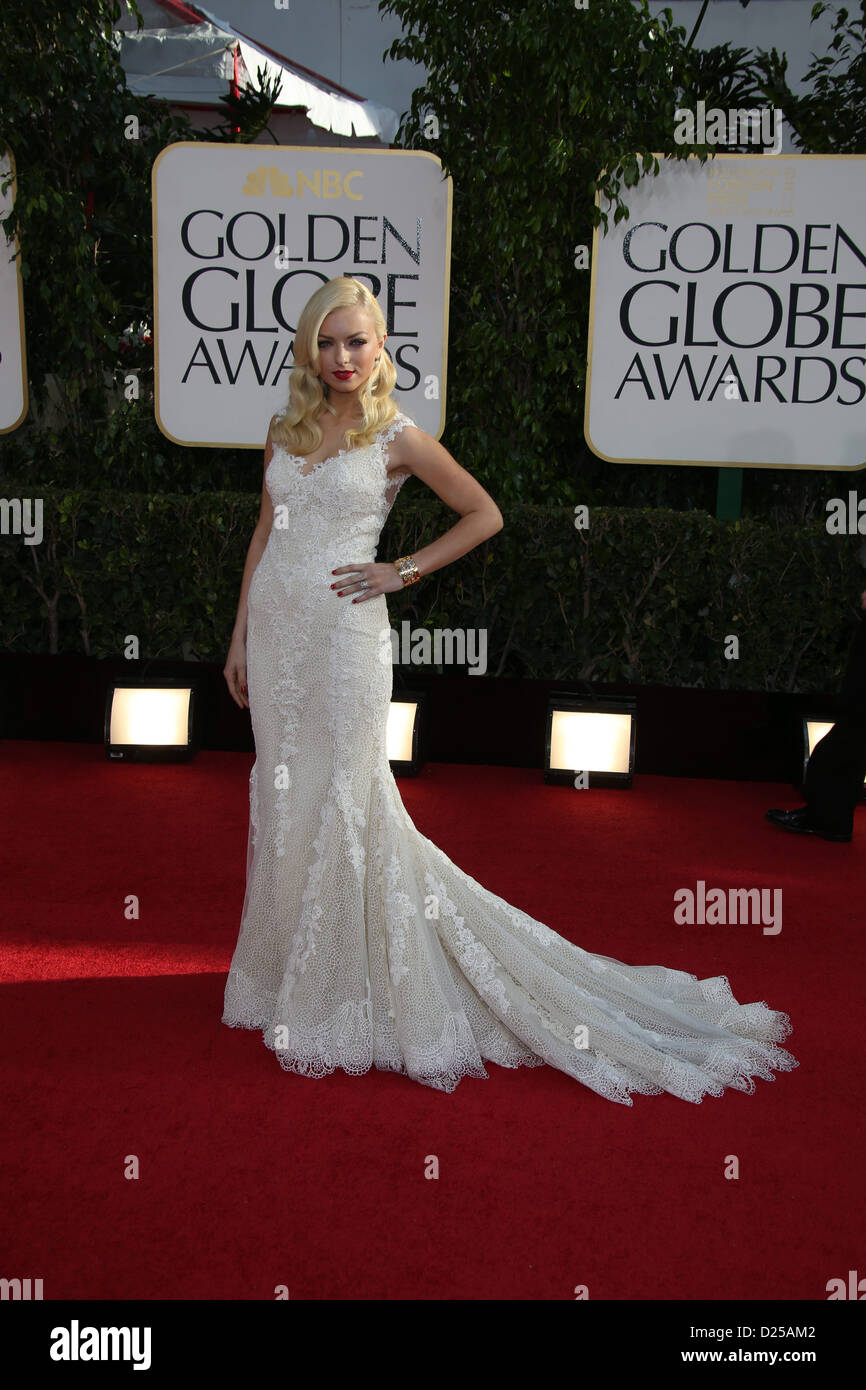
[0,480,866,691]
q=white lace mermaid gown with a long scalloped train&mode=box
[222,413,798,1105]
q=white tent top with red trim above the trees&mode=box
[121,0,399,145]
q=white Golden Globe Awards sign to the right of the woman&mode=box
[584,154,866,468]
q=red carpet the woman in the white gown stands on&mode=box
[0,742,866,1300]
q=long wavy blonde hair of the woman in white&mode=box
[271,275,398,457]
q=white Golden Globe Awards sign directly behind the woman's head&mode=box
[153,142,452,449]
